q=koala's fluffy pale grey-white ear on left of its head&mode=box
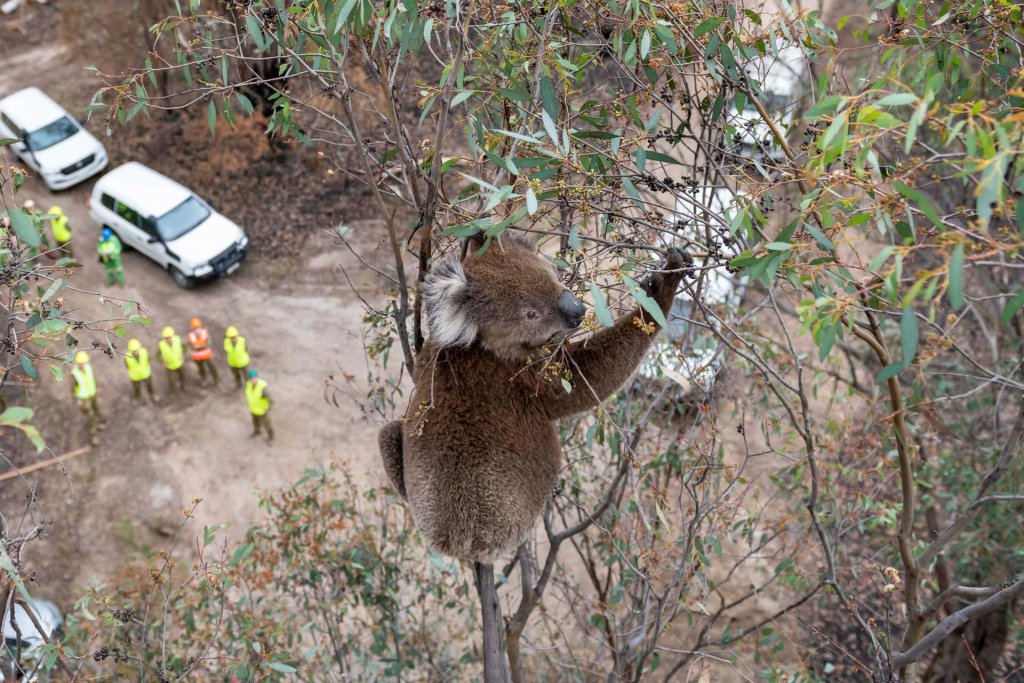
[422,255,478,348]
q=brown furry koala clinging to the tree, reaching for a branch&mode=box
[379,238,688,564]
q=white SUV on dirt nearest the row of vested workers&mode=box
[89,162,249,289]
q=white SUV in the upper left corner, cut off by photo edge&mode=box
[0,88,108,190]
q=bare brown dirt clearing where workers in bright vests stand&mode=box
[0,40,395,608]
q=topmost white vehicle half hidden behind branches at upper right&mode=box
[726,45,807,160]
